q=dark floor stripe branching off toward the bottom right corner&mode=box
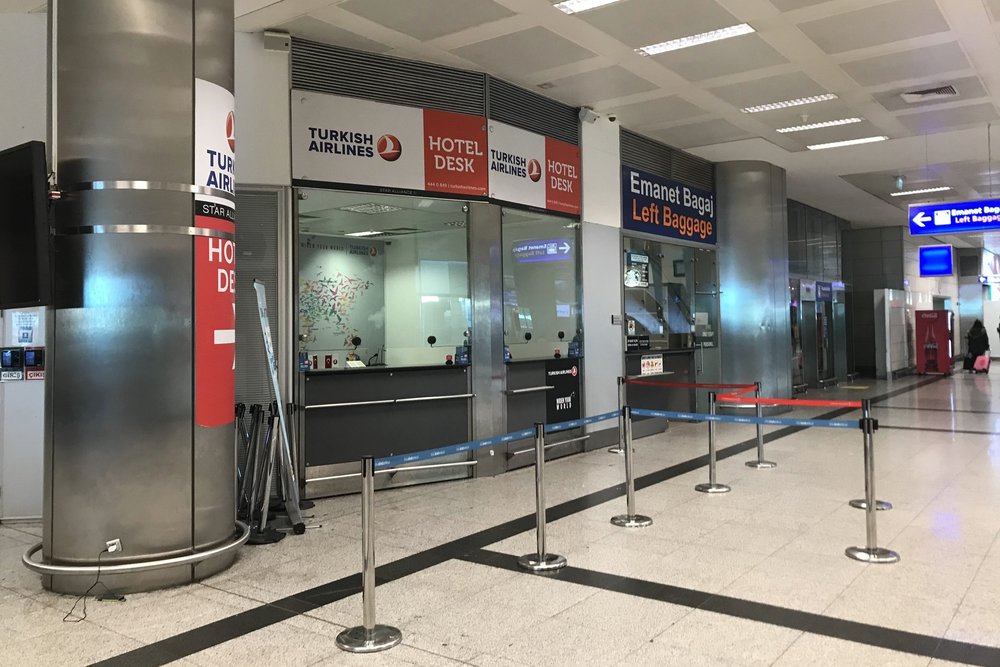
[462,549,1000,667]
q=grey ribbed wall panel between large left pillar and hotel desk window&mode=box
[236,190,281,405]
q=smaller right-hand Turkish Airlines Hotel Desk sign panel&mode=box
[489,121,580,215]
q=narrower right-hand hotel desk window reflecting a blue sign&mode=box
[502,209,583,361]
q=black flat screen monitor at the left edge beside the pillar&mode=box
[0,141,52,309]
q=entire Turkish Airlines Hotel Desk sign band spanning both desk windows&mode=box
[292,90,580,215]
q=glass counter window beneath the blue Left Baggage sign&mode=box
[622,237,696,350]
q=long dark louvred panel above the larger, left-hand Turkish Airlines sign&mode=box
[292,39,486,116]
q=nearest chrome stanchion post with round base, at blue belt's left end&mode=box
[337,456,403,653]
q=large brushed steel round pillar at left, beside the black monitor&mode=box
[43,0,235,592]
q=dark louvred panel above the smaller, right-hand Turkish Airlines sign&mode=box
[487,76,580,144]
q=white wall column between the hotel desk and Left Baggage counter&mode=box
[580,117,624,448]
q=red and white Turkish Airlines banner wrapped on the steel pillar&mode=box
[194,79,236,427]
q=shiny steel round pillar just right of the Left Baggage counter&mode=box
[715,160,792,398]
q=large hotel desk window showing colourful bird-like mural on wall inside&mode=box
[297,190,472,370]
